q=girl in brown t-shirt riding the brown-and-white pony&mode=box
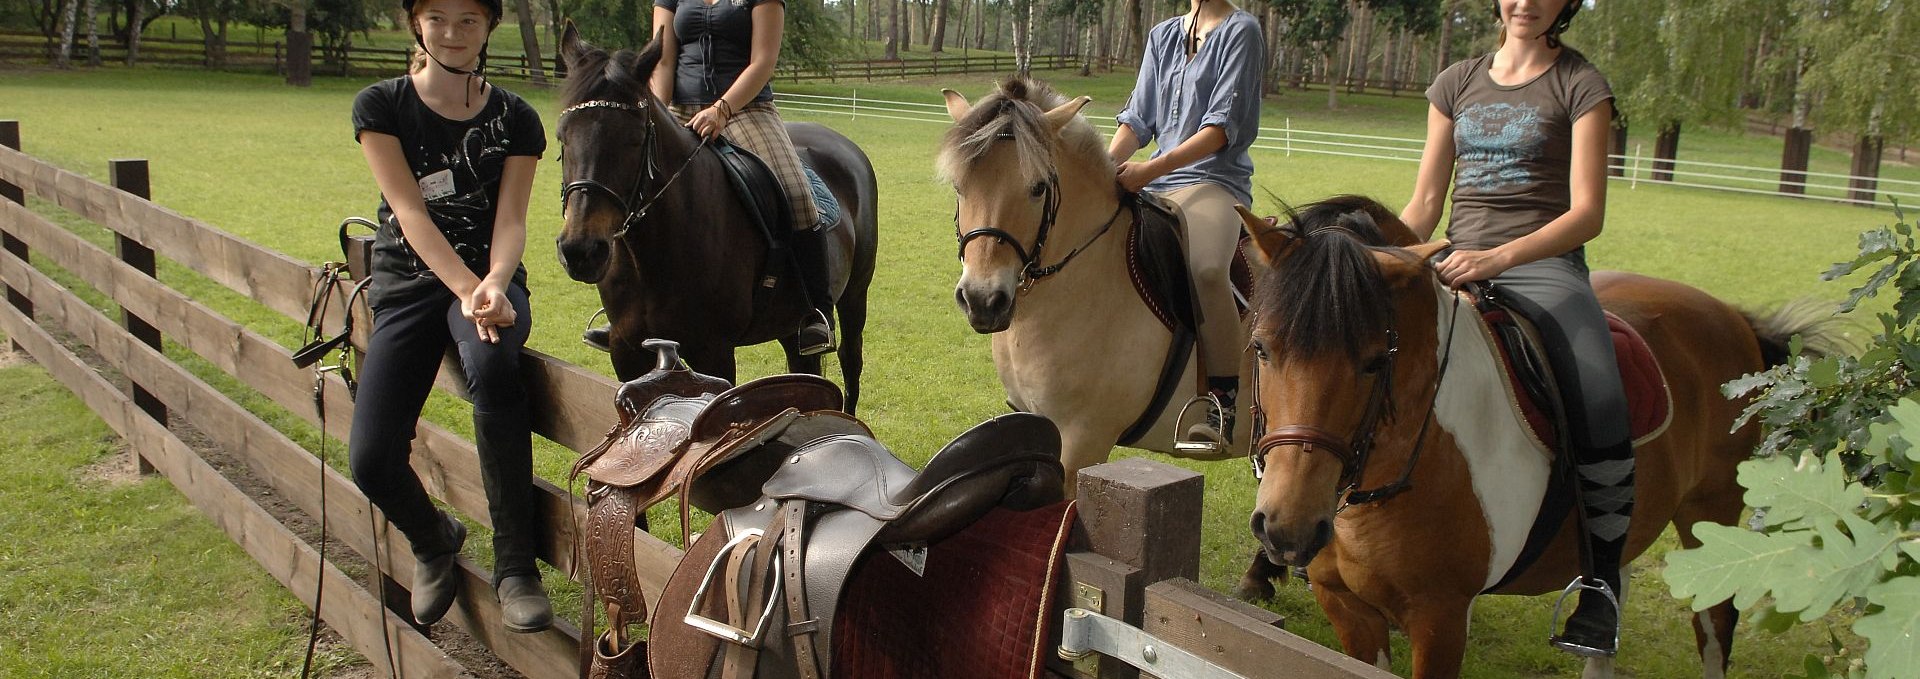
[1400,0,1634,658]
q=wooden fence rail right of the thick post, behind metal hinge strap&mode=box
[1140,579,1394,679]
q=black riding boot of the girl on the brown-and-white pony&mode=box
[1549,443,1634,658]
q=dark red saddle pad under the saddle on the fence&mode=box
[833,503,1073,679]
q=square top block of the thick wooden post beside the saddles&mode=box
[1077,457,1204,583]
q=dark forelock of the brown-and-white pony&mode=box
[1254,196,1407,361]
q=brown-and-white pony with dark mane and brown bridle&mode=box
[1248,198,1822,677]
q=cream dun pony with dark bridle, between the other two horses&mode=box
[937,79,1246,479]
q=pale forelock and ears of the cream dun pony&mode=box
[933,77,1112,182]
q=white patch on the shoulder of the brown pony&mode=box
[1434,284,1549,589]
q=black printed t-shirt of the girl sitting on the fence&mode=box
[353,75,547,307]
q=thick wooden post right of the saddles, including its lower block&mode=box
[1054,458,1204,679]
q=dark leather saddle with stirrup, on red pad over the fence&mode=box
[649,412,1064,679]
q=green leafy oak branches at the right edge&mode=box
[1667,208,1920,679]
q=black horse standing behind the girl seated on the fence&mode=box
[557,27,877,406]
